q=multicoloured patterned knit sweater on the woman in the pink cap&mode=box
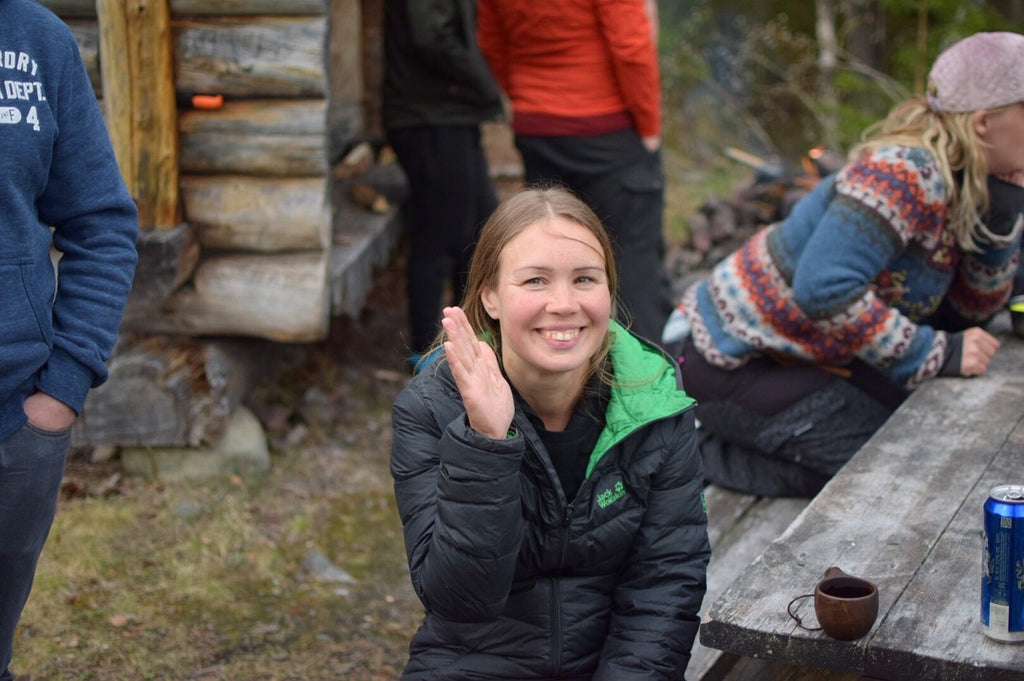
[682,146,1020,389]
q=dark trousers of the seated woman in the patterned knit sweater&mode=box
[681,340,907,497]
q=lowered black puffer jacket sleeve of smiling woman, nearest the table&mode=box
[594,410,711,681]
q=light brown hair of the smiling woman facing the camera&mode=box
[423,185,618,378]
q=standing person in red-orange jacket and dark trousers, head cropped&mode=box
[478,0,672,341]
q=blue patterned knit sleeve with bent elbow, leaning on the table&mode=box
[793,155,947,387]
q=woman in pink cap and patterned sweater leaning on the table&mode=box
[663,32,1024,497]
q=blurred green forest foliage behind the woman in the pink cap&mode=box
[659,0,1024,162]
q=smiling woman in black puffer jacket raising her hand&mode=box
[391,184,710,681]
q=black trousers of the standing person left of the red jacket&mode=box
[387,125,498,355]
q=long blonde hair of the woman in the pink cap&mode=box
[850,96,1009,251]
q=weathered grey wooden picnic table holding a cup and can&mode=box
[700,325,1024,681]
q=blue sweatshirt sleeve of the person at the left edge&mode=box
[37,23,138,412]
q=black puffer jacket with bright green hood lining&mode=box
[391,327,710,681]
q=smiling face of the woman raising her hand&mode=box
[480,217,611,383]
